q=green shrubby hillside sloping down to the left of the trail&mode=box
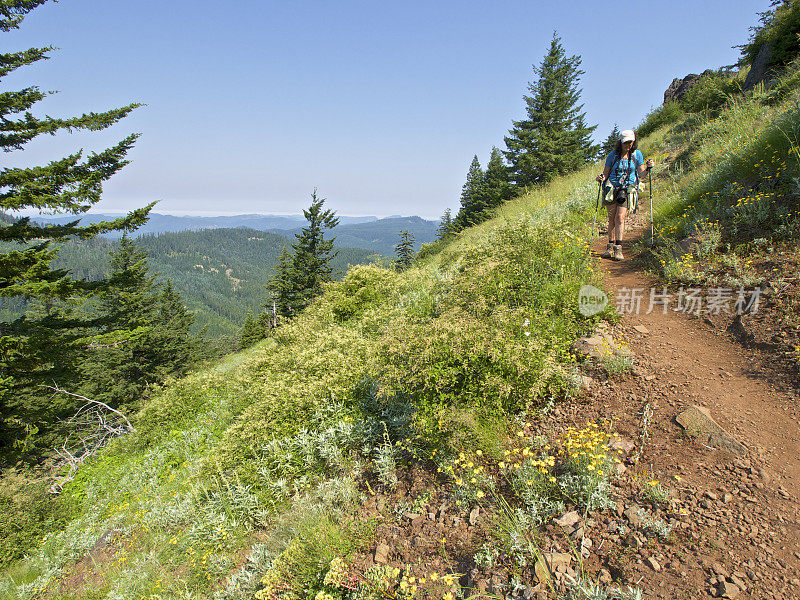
[2,162,603,598]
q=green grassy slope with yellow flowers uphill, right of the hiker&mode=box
[654,80,800,287]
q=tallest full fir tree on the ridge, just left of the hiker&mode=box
[505,32,598,187]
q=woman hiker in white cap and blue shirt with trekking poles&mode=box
[597,129,655,260]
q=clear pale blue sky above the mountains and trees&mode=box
[2,0,769,218]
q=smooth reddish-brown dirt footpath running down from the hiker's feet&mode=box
[594,215,800,497]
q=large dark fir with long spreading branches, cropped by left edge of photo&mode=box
[0,0,152,448]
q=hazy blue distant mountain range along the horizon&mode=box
[33,213,439,256]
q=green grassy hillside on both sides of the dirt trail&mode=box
[6,14,800,600]
